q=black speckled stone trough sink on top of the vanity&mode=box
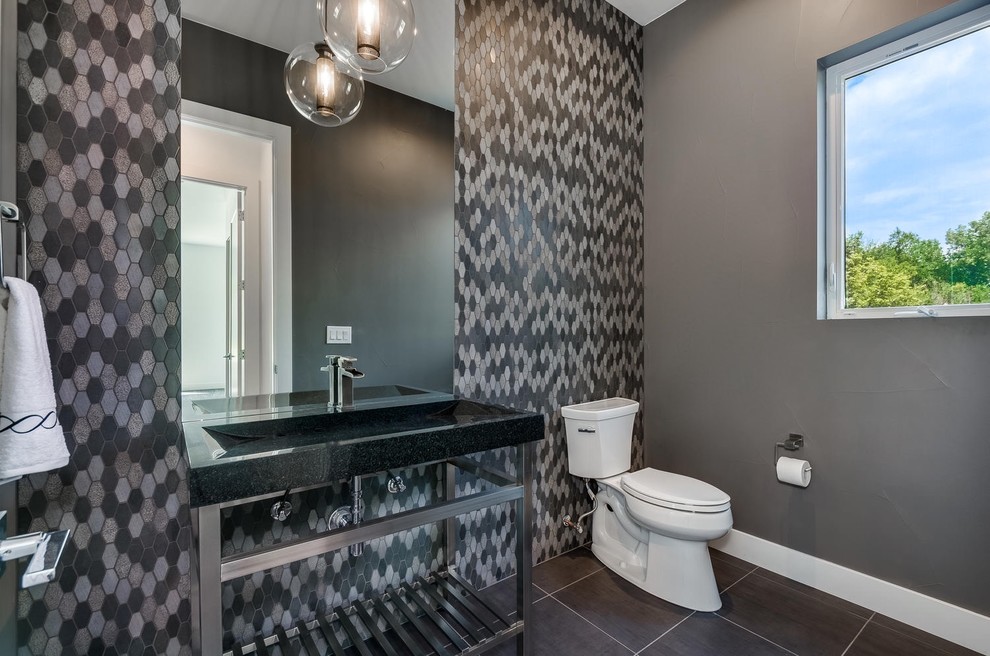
[183,400,544,507]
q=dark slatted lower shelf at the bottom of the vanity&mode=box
[232,572,523,656]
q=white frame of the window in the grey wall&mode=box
[818,6,990,319]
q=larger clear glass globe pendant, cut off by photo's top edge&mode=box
[316,0,416,75]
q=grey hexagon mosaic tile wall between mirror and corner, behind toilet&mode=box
[454,0,643,576]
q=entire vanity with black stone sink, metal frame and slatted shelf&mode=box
[183,399,545,656]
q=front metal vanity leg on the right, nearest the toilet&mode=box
[516,442,535,656]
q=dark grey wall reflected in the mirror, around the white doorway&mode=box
[182,21,454,391]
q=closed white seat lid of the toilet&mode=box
[621,467,730,513]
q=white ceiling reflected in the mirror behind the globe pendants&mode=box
[182,0,454,111]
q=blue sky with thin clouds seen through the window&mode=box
[846,28,990,243]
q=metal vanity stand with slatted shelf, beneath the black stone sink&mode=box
[194,442,534,656]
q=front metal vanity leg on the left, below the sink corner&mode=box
[193,505,223,656]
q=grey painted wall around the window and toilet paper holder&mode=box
[645,0,990,613]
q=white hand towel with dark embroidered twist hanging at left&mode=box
[0,278,69,479]
